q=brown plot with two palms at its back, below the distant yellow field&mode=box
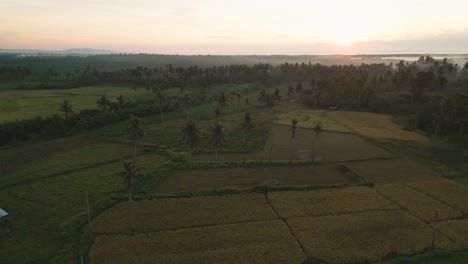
[257,126,394,161]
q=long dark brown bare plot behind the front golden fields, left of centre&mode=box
[156,164,353,194]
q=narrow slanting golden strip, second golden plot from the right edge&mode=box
[376,184,463,223]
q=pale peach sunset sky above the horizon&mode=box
[0,0,468,55]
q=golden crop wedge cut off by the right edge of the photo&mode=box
[408,179,468,214]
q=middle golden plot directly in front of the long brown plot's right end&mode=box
[268,187,398,218]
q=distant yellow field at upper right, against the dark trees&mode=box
[327,111,428,142]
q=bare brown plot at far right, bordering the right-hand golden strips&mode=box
[346,159,440,184]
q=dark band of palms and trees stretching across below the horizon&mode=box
[0,57,468,145]
